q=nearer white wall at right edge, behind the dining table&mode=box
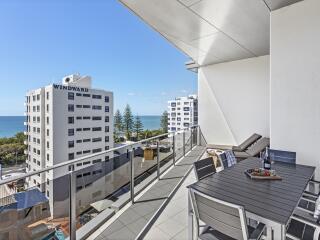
[271,0,320,177]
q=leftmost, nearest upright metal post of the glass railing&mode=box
[69,165,77,240]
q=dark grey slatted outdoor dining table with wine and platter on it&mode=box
[188,157,315,240]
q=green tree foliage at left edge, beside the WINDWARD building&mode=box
[0,132,27,167]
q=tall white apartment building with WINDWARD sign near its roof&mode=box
[25,74,113,216]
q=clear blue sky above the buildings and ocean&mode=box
[0,0,197,116]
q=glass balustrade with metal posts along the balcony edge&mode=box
[0,127,200,239]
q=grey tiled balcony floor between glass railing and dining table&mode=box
[90,146,204,240]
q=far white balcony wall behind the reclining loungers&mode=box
[198,56,270,144]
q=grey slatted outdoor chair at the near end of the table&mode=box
[189,189,265,240]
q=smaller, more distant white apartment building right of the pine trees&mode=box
[168,95,198,133]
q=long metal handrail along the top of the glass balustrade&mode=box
[0,125,198,185]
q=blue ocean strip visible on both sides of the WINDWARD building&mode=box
[0,116,161,137]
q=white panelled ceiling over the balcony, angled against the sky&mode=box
[120,0,299,65]
